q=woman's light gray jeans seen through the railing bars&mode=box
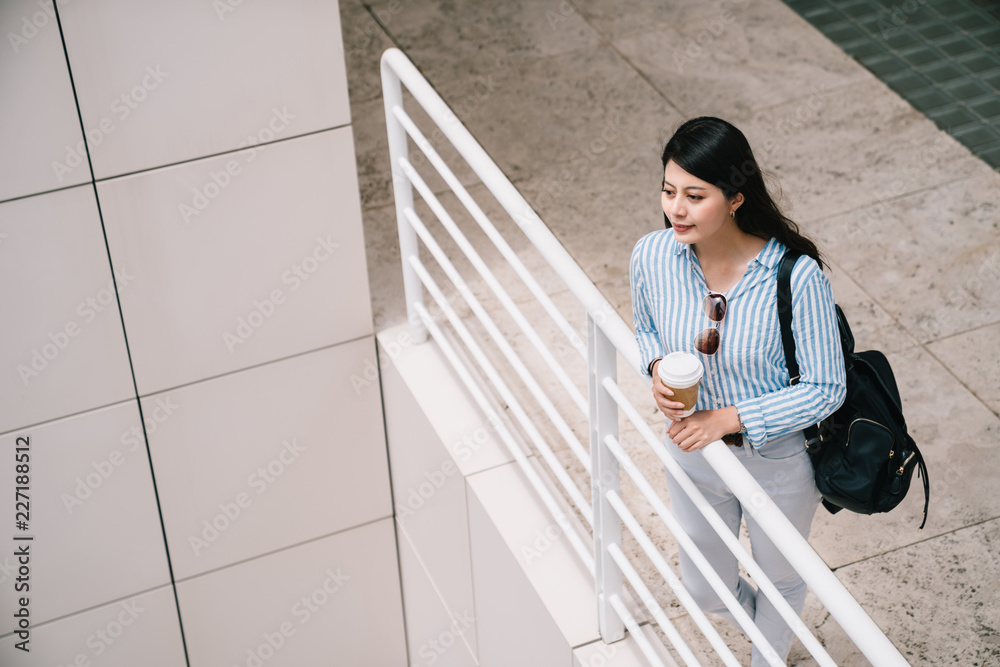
[666,431,821,667]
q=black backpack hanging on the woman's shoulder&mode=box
[778,251,930,529]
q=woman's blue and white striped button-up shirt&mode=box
[630,229,846,447]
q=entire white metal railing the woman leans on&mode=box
[382,49,908,666]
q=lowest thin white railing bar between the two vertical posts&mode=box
[414,302,594,576]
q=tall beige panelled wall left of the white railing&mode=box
[0,0,406,667]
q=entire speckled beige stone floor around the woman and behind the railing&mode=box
[341,0,1000,665]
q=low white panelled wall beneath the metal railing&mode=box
[377,325,672,667]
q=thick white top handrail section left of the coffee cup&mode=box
[382,49,642,372]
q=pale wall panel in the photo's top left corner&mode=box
[0,0,90,201]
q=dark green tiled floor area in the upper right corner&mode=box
[784,0,1000,170]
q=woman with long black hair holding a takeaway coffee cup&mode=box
[631,117,845,666]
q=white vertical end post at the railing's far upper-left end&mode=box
[382,51,427,344]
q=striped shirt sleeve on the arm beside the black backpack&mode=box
[736,259,847,448]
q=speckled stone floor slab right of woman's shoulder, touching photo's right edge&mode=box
[807,167,1000,342]
